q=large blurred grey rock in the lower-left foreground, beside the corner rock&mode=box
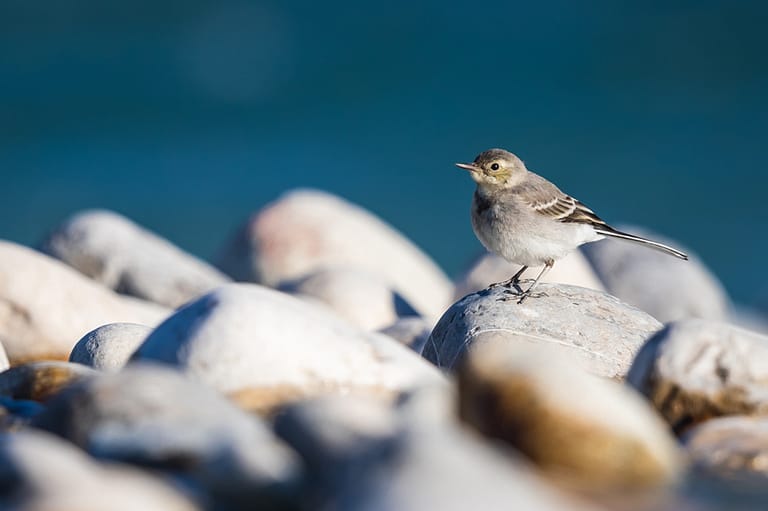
[32,364,299,505]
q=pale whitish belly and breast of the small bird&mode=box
[472,199,603,266]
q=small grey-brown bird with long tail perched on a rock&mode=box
[456,149,688,303]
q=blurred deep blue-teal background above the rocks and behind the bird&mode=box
[0,0,768,308]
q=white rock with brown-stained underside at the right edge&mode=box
[627,319,768,431]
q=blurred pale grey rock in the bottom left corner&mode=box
[0,430,201,511]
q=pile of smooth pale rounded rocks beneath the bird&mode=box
[0,189,768,511]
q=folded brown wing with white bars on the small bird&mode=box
[520,173,608,228]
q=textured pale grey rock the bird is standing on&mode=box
[423,284,661,379]
